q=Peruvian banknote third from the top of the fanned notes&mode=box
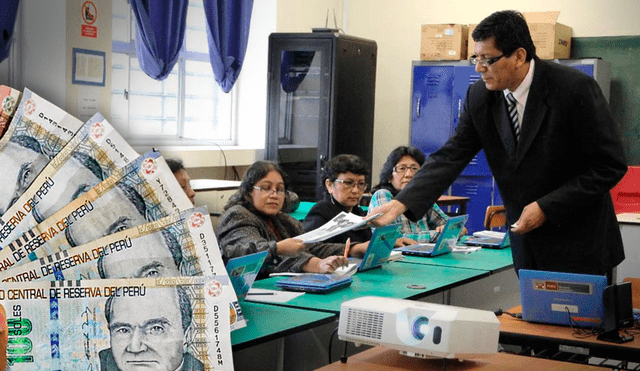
[0,113,139,246]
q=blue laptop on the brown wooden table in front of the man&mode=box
[519,269,607,327]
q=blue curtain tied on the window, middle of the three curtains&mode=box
[131,0,189,80]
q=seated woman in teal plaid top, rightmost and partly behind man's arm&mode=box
[369,146,448,247]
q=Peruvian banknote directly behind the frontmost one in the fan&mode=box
[0,206,246,330]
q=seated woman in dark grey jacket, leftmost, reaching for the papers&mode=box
[216,161,366,278]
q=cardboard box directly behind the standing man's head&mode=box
[467,12,573,59]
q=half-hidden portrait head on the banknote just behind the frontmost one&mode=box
[97,229,182,278]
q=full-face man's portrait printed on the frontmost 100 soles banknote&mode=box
[99,286,204,371]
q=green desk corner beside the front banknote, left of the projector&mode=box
[231,295,337,351]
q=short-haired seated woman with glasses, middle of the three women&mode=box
[303,155,371,243]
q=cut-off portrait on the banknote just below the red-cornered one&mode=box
[0,135,50,215]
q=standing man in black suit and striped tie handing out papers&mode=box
[374,11,627,275]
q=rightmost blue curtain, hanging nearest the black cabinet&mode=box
[204,0,253,93]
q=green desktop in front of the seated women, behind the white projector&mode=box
[248,262,490,314]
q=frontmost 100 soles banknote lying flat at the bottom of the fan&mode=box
[0,276,233,371]
